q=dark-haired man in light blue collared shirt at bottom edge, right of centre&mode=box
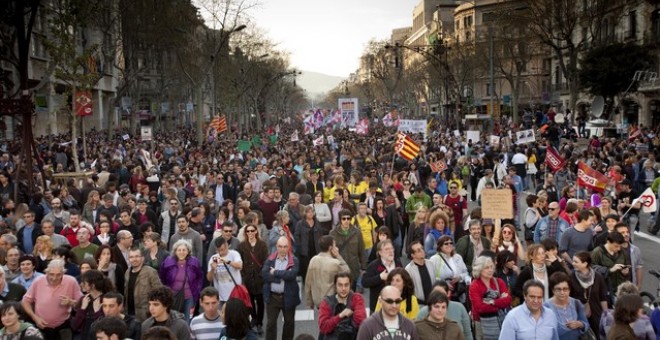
[500,280,559,340]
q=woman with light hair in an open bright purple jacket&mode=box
[158,240,204,323]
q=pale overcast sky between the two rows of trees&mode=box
[249,0,419,77]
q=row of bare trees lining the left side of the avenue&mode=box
[0,0,306,164]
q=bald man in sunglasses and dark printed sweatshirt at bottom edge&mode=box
[357,286,419,340]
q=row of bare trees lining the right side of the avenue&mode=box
[329,0,653,120]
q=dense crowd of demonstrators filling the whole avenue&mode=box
[0,118,660,340]
